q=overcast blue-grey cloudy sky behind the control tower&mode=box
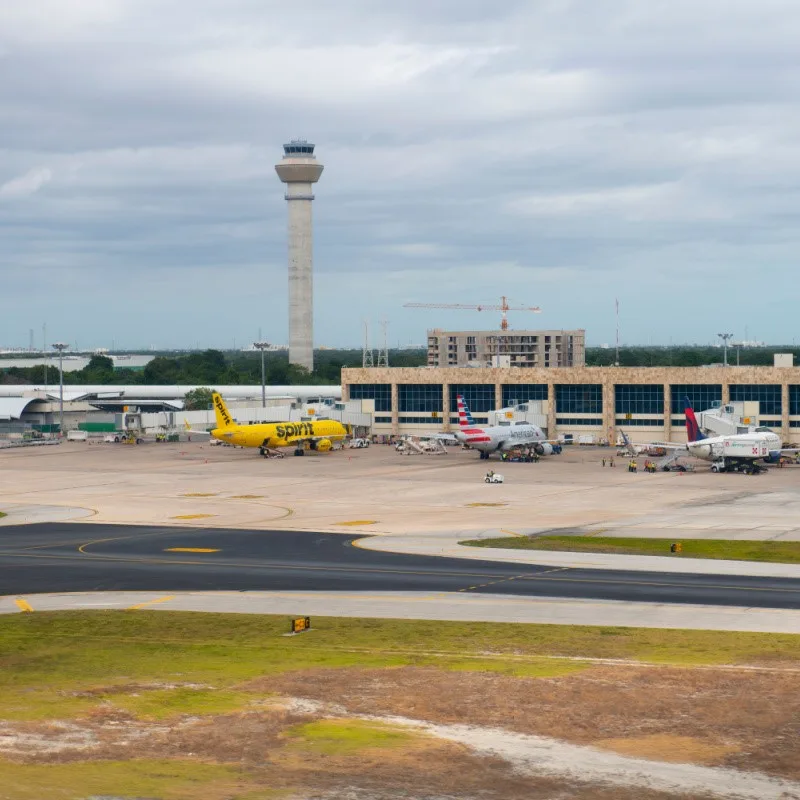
[0,0,800,347]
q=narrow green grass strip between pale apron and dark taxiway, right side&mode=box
[461,536,800,564]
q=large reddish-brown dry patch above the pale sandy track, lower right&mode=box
[262,667,800,780]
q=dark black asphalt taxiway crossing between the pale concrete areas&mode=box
[0,523,800,609]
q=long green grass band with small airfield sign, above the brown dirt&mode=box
[0,611,800,720]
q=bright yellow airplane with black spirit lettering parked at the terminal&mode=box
[186,393,349,456]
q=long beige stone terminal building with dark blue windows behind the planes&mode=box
[342,364,800,442]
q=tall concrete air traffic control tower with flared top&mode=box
[275,139,323,372]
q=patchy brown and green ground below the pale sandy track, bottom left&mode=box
[0,709,696,800]
